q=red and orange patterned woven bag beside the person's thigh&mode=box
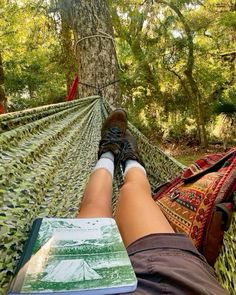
[154,149,236,262]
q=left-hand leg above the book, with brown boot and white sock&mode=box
[77,109,127,218]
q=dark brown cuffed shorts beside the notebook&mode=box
[121,234,227,295]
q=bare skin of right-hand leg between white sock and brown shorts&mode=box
[115,167,174,247]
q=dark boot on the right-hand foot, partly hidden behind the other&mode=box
[119,130,144,170]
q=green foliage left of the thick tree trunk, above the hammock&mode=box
[0,0,70,111]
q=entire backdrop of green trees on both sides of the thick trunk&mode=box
[0,0,236,146]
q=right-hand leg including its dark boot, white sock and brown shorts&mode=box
[116,133,225,294]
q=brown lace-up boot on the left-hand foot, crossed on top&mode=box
[98,109,127,164]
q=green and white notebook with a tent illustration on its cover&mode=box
[8,218,137,295]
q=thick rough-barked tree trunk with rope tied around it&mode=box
[72,0,120,103]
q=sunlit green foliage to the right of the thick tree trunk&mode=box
[110,0,235,147]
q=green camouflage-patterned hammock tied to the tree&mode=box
[0,96,236,293]
